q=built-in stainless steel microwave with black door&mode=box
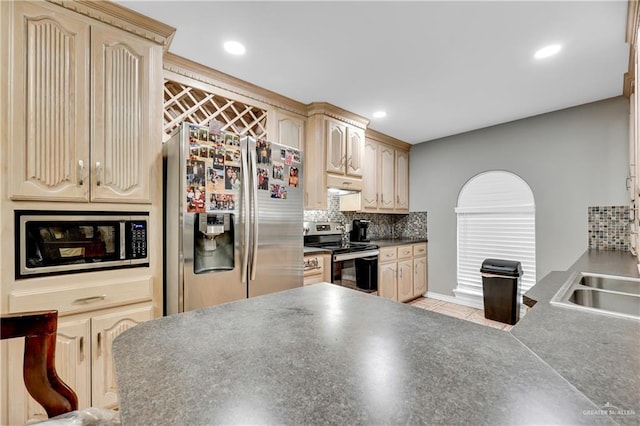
[15,210,149,278]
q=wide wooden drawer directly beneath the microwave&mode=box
[9,276,153,315]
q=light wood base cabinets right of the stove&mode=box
[378,243,427,302]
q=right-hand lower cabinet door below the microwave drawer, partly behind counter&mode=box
[91,306,153,408]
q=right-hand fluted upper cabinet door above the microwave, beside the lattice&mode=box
[91,26,162,202]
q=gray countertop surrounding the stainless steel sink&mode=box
[511,250,640,425]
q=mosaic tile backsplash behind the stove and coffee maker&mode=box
[304,194,427,240]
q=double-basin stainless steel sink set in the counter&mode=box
[551,272,640,320]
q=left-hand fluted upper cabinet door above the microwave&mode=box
[8,2,89,201]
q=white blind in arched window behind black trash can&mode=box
[454,171,536,306]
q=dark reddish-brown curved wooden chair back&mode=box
[0,310,78,418]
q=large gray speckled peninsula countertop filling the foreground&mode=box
[113,283,620,425]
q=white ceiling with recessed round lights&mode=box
[117,0,629,143]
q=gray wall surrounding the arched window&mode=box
[410,97,629,296]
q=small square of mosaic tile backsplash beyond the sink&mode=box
[588,206,631,251]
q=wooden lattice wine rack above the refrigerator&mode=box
[163,79,267,139]
